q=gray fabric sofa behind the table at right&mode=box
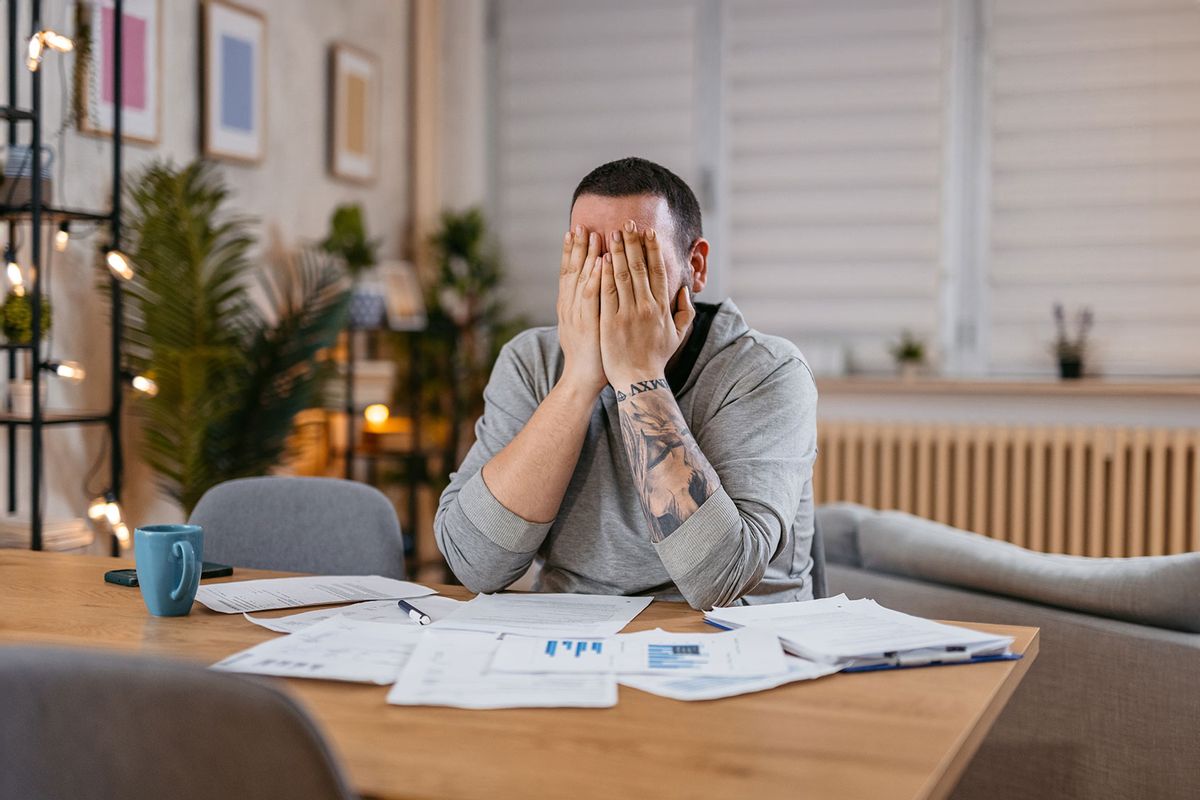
[817,504,1200,800]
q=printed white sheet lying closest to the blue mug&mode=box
[196,575,433,614]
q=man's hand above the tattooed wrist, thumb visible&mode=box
[600,221,696,399]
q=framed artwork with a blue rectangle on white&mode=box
[200,0,266,163]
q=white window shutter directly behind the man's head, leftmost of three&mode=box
[493,0,698,323]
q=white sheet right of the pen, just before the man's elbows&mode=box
[431,594,654,638]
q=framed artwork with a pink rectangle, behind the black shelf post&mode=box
[76,0,162,144]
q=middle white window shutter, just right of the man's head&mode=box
[716,0,947,368]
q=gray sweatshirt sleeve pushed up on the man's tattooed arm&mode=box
[654,359,817,609]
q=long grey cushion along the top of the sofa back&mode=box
[857,511,1200,633]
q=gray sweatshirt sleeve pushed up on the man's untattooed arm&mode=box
[433,339,552,593]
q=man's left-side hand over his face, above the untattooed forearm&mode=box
[558,225,606,399]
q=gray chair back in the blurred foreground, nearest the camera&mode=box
[0,646,353,800]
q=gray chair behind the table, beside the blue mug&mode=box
[190,477,404,578]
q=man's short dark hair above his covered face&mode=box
[571,156,703,259]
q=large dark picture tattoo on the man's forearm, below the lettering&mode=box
[617,378,720,542]
